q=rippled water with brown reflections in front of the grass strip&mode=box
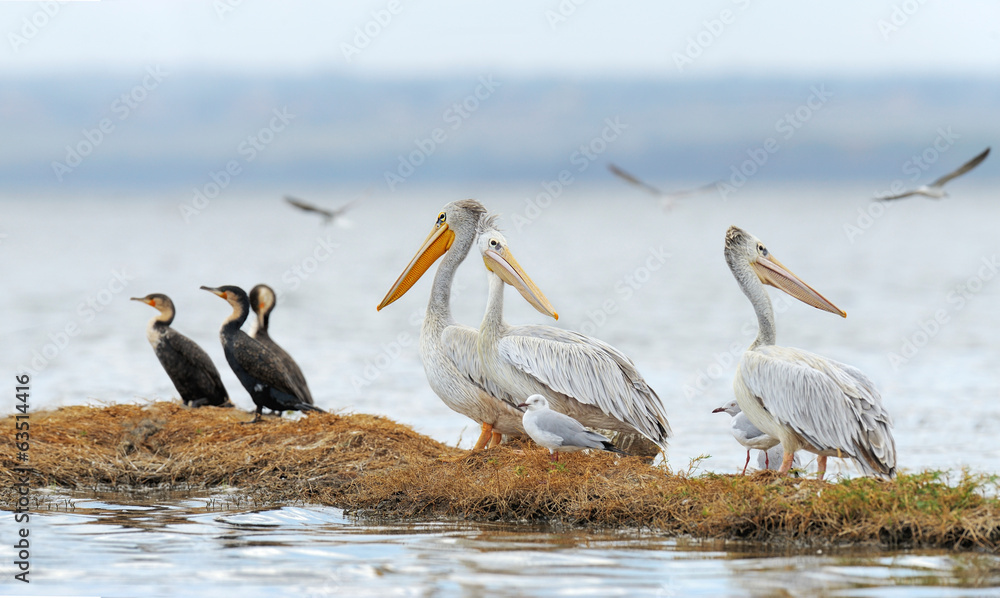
[5,495,1000,598]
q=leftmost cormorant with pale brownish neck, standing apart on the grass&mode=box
[132,293,232,407]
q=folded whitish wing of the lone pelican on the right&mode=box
[740,346,896,476]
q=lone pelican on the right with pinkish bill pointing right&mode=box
[725,226,896,479]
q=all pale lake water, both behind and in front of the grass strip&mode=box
[0,186,1000,596]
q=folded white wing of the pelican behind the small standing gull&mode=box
[498,326,670,441]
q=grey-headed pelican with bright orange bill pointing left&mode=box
[377,199,527,450]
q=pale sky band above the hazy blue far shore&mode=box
[0,0,1000,77]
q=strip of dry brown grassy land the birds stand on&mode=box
[0,403,1000,552]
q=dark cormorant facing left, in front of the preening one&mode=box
[201,285,323,422]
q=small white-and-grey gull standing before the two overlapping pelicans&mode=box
[518,395,628,461]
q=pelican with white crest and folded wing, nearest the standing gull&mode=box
[479,217,670,456]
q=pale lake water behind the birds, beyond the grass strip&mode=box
[0,182,1000,474]
